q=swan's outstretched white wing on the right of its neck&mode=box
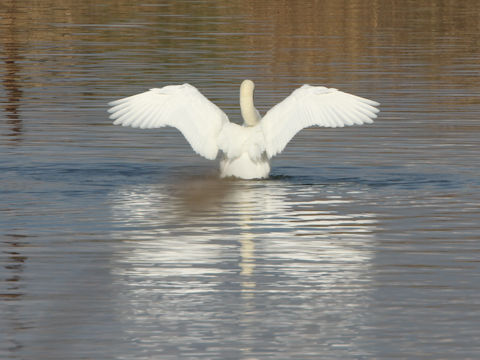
[260,85,379,158]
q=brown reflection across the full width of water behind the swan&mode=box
[0,0,480,119]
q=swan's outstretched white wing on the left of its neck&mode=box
[108,84,229,160]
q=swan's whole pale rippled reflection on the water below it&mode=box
[112,179,376,355]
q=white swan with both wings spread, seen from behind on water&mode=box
[108,80,379,179]
